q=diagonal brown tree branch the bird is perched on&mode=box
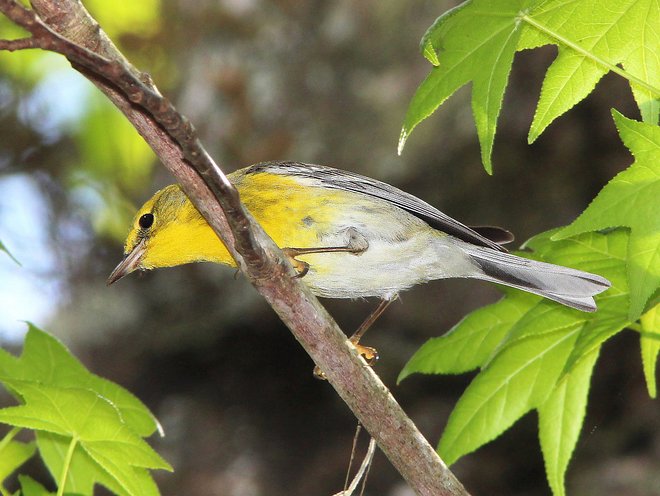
[0,0,467,496]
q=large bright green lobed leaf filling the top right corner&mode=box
[399,0,660,172]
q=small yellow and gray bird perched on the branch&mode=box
[108,162,610,312]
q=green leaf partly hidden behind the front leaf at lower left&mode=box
[0,324,159,436]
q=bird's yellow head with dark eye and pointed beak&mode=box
[108,184,235,284]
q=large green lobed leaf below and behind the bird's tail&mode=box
[400,230,629,494]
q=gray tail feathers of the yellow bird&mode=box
[464,246,611,312]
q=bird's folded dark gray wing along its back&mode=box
[245,162,512,251]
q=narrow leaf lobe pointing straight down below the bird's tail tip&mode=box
[538,350,598,496]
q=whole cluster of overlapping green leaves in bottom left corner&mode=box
[0,325,171,495]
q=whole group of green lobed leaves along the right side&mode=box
[399,0,660,495]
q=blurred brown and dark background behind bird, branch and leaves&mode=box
[0,0,660,496]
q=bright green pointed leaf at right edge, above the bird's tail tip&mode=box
[555,111,660,321]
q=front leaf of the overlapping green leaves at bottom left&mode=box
[0,380,171,495]
